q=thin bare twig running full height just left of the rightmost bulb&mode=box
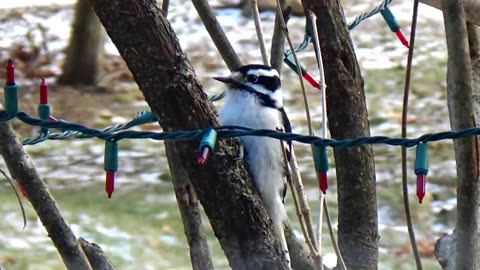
[402,0,422,270]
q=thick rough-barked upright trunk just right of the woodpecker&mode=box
[303,0,378,269]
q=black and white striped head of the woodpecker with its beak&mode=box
[214,65,283,108]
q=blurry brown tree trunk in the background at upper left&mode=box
[58,0,105,85]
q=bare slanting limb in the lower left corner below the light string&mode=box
[0,109,91,270]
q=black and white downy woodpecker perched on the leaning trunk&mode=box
[214,65,291,265]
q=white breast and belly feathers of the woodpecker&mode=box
[219,90,286,225]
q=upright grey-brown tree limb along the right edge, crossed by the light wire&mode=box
[442,0,480,269]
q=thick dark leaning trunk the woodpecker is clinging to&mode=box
[91,0,287,269]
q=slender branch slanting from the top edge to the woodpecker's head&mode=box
[192,0,242,70]
